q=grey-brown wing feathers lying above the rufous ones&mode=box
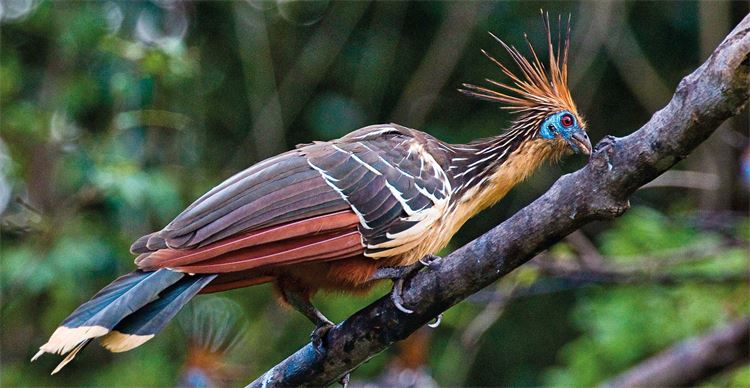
[140,150,349,253]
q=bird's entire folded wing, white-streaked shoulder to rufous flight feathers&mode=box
[131,126,451,273]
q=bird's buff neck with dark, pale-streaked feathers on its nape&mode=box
[449,129,563,218]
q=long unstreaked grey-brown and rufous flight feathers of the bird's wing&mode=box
[131,150,364,273]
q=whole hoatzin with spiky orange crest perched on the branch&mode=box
[34,17,591,373]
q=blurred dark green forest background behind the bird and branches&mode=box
[0,0,750,386]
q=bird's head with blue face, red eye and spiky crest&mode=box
[460,13,591,155]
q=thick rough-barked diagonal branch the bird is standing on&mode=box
[249,16,750,387]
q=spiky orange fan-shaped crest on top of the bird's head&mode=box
[459,11,578,116]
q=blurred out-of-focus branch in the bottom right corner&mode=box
[603,317,750,388]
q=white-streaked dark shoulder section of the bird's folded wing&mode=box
[306,125,452,258]
